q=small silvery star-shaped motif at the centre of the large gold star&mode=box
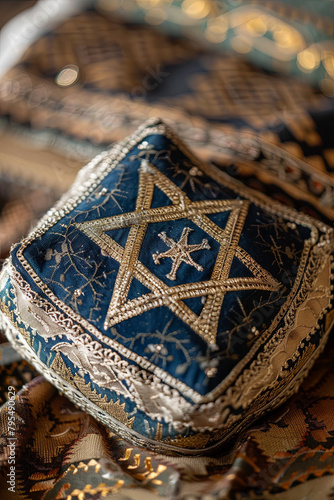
[152,227,210,281]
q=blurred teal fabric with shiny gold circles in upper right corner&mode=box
[97,0,334,87]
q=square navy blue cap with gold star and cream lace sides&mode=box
[0,120,333,454]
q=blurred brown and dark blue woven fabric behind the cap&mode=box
[0,7,334,223]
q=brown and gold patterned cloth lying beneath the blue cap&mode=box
[0,336,334,500]
